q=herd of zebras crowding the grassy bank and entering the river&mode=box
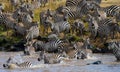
[0,0,120,68]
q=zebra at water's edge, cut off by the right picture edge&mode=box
[107,41,120,61]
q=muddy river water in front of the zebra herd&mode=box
[0,52,120,72]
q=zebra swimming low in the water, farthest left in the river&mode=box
[3,57,33,69]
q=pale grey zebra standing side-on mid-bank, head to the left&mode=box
[46,20,70,35]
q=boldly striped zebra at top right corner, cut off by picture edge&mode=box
[102,5,120,17]
